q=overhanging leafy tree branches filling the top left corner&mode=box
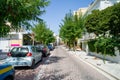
[0,0,49,36]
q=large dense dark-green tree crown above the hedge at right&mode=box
[85,3,120,36]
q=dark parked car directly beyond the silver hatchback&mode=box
[36,44,50,57]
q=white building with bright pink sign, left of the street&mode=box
[0,31,30,52]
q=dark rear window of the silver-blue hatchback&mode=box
[10,47,29,57]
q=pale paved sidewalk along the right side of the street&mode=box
[62,47,120,80]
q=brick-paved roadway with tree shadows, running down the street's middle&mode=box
[35,47,109,80]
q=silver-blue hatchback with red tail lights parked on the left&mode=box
[5,46,42,68]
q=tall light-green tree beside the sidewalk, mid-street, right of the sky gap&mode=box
[60,12,84,48]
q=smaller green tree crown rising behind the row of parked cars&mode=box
[32,22,55,44]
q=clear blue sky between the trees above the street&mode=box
[41,0,94,35]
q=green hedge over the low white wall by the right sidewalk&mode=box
[88,37,116,56]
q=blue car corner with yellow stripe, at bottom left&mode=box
[0,64,15,80]
